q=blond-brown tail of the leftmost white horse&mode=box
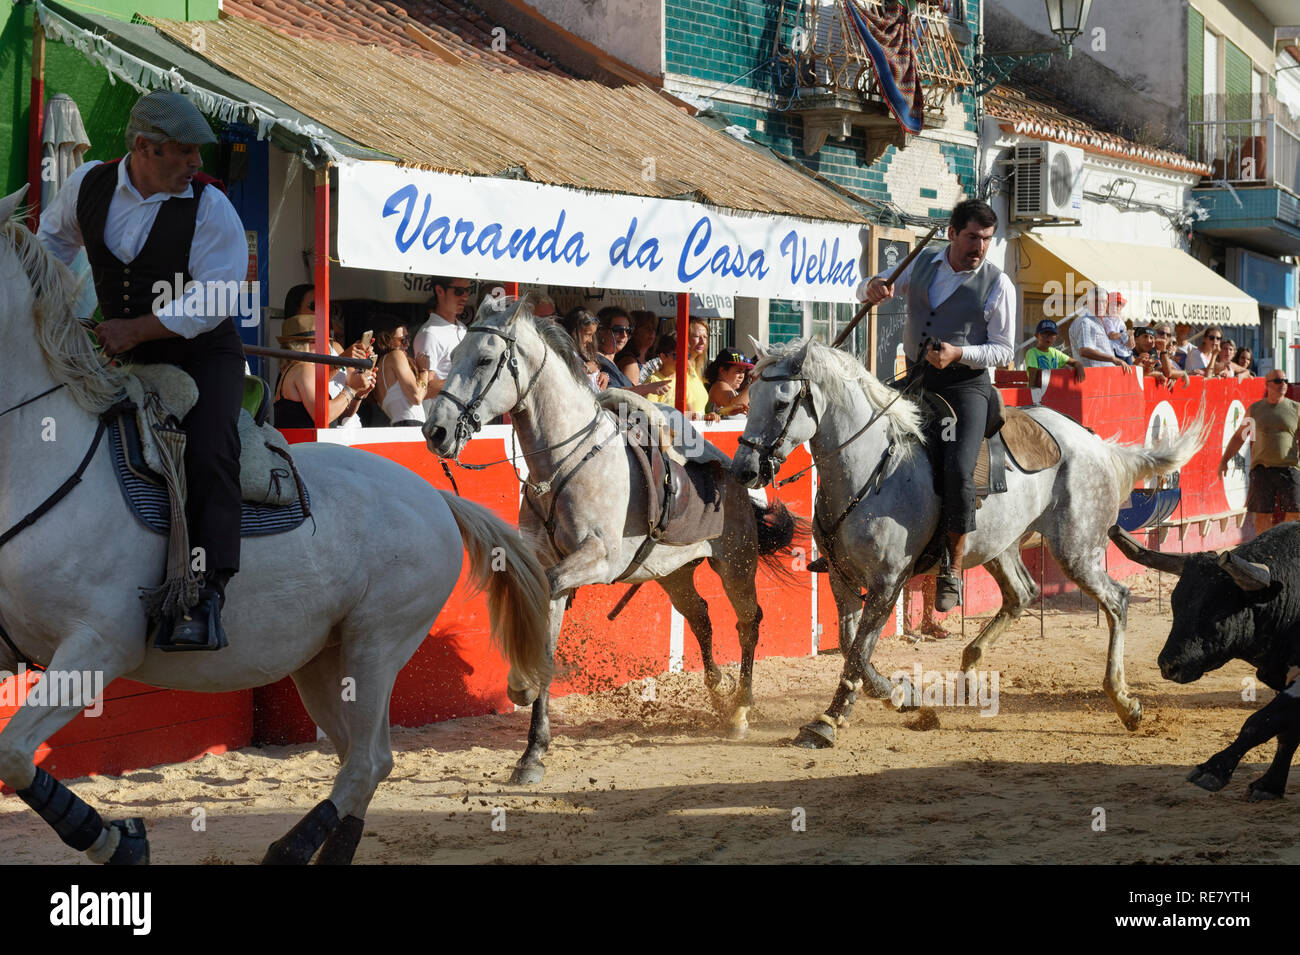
[442,491,553,706]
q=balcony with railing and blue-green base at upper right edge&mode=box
[1187,94,1300,256]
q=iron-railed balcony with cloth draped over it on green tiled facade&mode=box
[774,0,971,164]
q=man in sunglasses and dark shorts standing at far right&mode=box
[1219,368,1300,534]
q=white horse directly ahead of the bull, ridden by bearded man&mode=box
[732,340,1205,748]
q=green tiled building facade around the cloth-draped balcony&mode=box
[664,0,980,342]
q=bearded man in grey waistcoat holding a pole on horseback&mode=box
[858,199,1015,612]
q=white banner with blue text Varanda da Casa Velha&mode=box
[338,160,868,301]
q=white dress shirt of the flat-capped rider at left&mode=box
[39,157,248,338]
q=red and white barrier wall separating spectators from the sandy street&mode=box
[0,368,1264,777]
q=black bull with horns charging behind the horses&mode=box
[1110,524,1300,800]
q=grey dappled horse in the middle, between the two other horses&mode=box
[424,296,793,782]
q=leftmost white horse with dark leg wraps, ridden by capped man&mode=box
[0,192,550,863]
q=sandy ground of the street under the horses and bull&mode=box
[0,574,1300,864]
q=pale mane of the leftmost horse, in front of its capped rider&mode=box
[0,217,127,414]
